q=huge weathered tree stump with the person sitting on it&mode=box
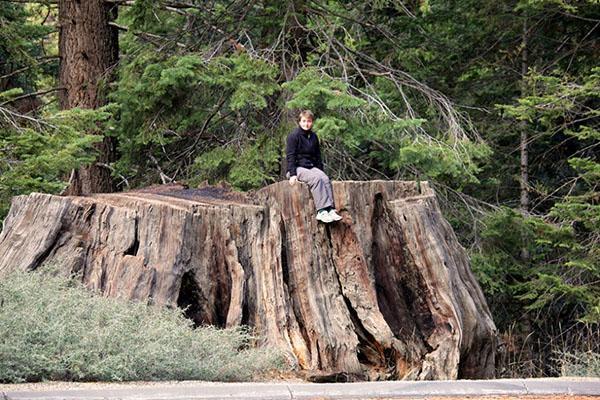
[0,181,496,379]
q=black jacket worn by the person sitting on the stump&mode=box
[286,127,323,176]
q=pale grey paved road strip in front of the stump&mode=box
[0,378,600,400]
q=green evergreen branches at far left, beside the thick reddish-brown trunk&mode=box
[0,2,110,218]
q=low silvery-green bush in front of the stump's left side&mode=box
[0,272,282,382]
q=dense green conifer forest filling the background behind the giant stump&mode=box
[0,0,600,377]
